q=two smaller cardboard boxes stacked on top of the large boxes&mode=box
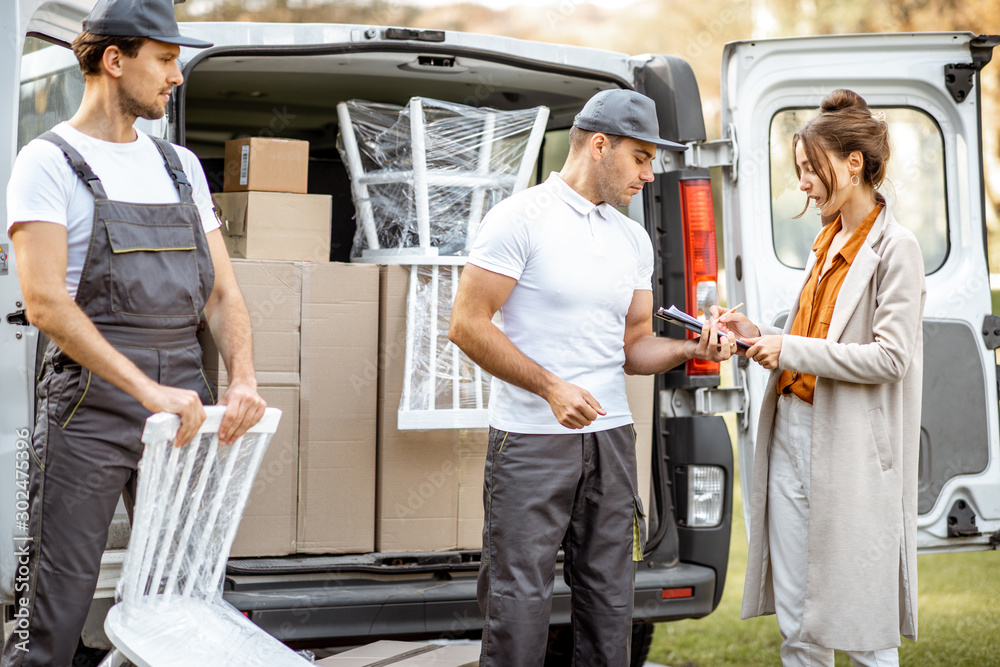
[213,137,332,262]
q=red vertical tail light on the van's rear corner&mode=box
[680,178,719,375]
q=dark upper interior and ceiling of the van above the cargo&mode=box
[176,49,614,262]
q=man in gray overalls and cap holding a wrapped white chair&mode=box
[2,0,265,667]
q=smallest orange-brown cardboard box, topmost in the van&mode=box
[222,137,309,194]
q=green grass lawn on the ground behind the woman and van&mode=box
[649,415,1000,667]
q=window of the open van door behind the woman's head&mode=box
[770,108,948,274]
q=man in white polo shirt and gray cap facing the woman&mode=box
[449,90,736,667]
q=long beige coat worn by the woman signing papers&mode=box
[742,206,926,651]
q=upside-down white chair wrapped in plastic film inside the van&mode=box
[337,97,549,429]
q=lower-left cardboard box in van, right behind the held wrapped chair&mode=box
[230,386,299,557]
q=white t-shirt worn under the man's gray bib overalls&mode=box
[7,123,219,298]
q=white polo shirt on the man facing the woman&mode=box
[469,172,653,434]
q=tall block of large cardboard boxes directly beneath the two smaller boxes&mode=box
[201,260,379,557]
